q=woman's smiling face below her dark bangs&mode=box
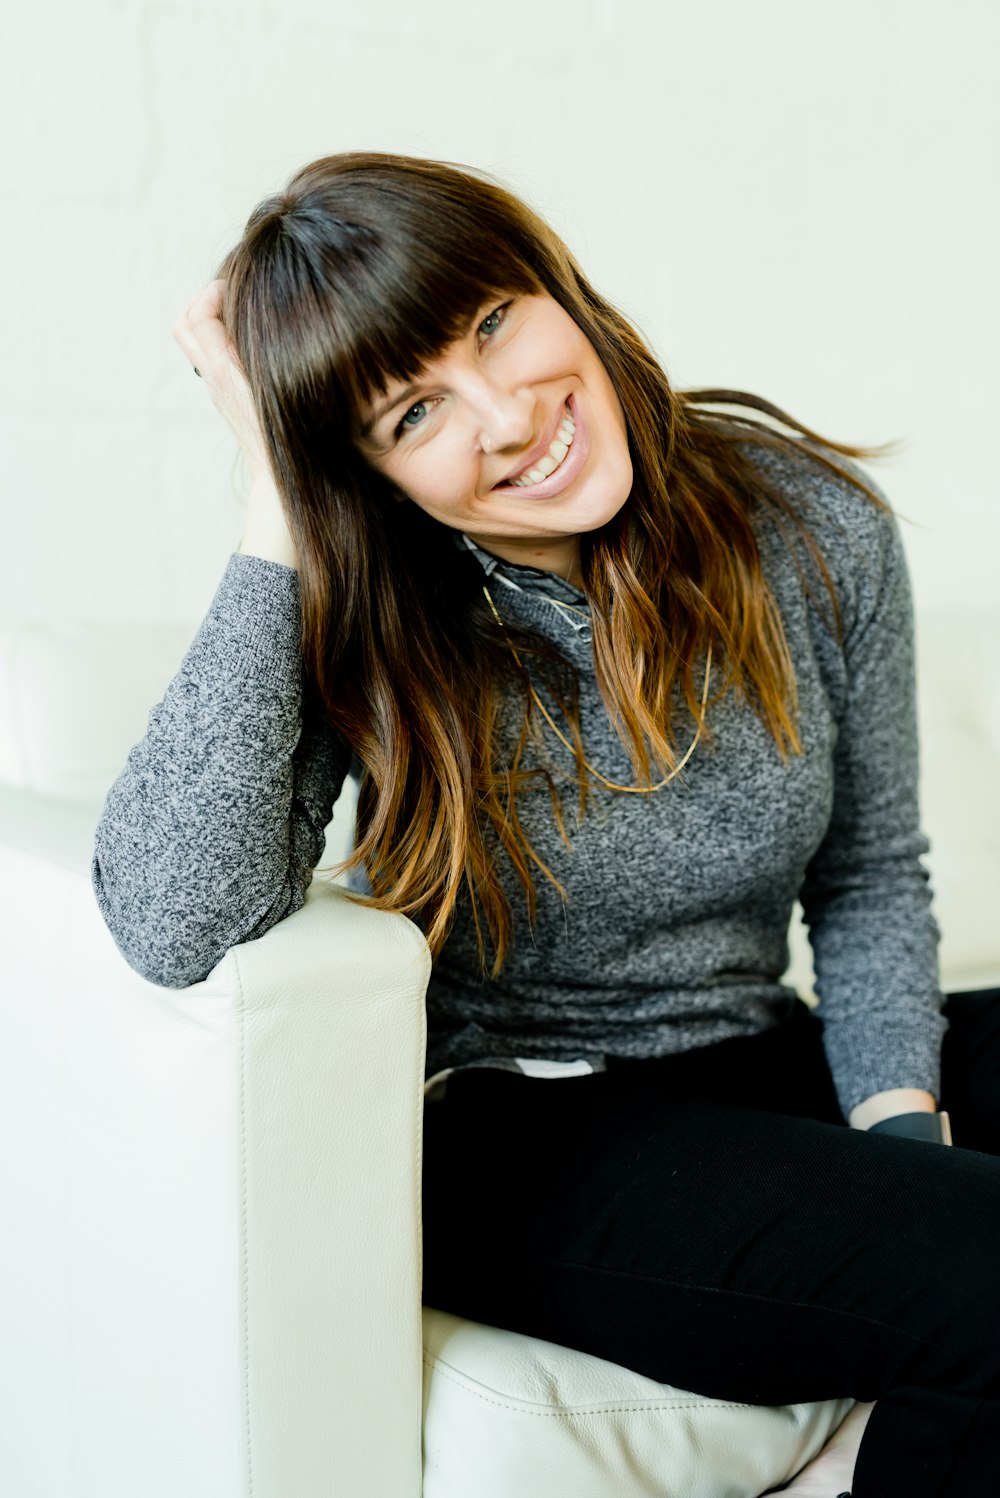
[358,295,632,577]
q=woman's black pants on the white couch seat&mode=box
[424,990,1000,1498]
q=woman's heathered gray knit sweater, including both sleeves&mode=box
[93,445,946,1115]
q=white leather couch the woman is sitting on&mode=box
[0,602,1000,1498]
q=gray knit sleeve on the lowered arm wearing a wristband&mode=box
[801,502,946,1118]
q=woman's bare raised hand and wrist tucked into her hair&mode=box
[174,280,298,568]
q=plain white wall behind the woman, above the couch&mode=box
[0,0,1000,625]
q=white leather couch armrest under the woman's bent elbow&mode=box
[0,792,430,1498]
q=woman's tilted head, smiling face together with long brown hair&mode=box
[219,153,882,978]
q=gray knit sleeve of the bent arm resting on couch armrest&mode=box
[91,553,350,989]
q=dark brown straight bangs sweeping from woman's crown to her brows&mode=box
[242,163,543,440]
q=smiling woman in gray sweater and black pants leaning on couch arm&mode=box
[94,146,1000,1498]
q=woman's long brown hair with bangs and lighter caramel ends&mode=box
[219,153,885,977]
